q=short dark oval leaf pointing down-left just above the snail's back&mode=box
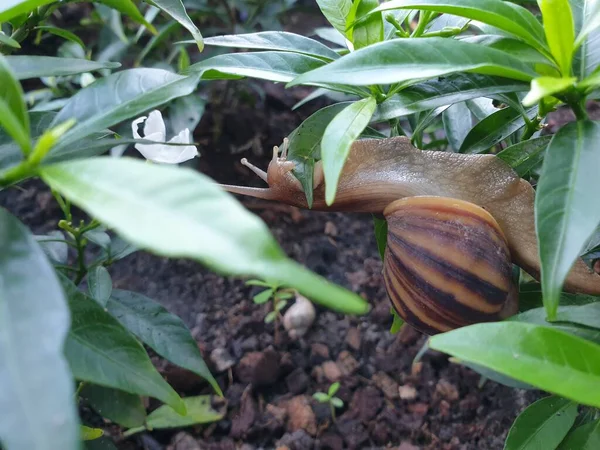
[460,106,538,153]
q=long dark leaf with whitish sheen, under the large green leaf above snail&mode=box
[372,74,529,122]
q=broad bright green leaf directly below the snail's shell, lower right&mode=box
[429,321,600,407]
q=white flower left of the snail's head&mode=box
[131,110,198,164]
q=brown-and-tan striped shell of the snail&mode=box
[383,196,518,335]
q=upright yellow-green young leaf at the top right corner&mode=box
[538,0,575,77]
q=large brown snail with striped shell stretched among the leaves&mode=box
[221,136,600,334]
